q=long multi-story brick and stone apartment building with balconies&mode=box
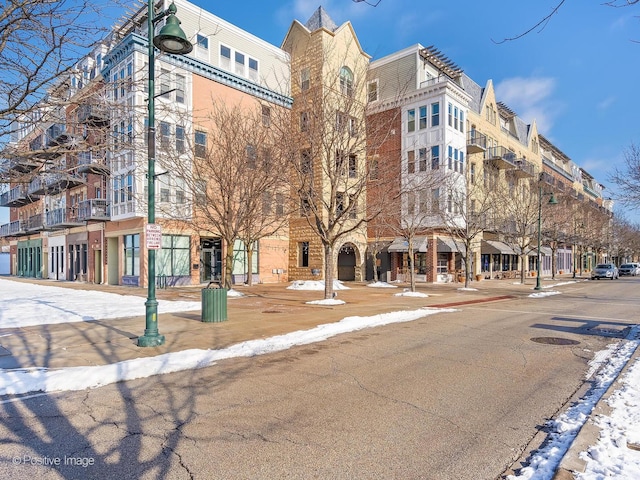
[0,0,612,285]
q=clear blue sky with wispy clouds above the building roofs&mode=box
[0,0,640,223]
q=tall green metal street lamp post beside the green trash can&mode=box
[138,0,193,347]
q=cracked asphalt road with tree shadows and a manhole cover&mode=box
[0,278,640,480]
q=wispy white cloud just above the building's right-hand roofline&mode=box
[495,77,559,133]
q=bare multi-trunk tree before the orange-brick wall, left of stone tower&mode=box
[164,99,289,288]
